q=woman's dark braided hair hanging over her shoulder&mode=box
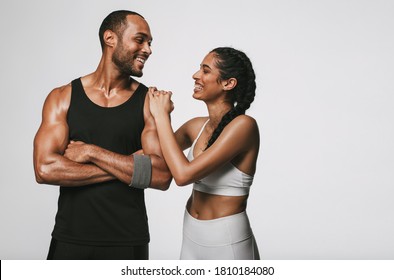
[206,47,256,149]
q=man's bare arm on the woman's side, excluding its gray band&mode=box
[65,94,172,190]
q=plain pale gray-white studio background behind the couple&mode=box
[0,0,394,259]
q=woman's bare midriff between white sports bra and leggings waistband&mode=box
[186,190,248,220]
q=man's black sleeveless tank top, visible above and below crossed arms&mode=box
[52,79,149,246]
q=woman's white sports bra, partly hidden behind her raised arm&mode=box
[187,119,253,196]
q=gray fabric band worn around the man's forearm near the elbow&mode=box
[130,154,152,189]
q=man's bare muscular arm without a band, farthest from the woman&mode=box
[33,85,115,187]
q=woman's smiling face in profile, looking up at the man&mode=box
[193,53,223,101]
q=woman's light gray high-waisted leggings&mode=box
[180,210,260,260]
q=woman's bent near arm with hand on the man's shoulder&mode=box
[150,91,258,186]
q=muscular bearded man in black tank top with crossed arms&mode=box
[34,11,172,259]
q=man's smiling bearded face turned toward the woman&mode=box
[112,15,152,77]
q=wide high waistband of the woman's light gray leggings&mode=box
[183,210,253,246]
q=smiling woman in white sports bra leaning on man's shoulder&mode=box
[149,47,260,259]
